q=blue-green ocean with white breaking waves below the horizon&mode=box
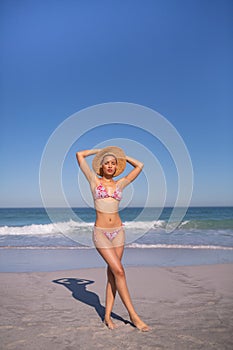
[0,207,233,251]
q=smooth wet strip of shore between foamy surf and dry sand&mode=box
[0,248,233,273]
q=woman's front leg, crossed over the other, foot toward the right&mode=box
[97,248,149,331]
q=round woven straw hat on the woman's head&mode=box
[92,146,126,177]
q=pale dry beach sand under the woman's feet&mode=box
[0,264,233,350]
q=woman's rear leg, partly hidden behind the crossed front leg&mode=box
[104,246,124,329]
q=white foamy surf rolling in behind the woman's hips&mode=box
[0,220,233,251]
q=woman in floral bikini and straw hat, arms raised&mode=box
[76,146,149,331]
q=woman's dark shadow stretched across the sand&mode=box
[52,278,131,324]
